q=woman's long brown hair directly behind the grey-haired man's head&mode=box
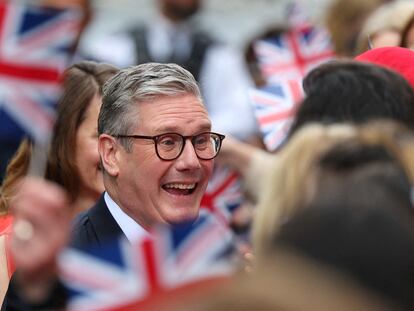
[45,61,118,200]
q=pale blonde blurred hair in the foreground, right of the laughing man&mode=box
[252,123,356,256]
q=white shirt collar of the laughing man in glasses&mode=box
[104,192,149,242]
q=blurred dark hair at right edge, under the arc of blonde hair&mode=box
[312,141,414,213]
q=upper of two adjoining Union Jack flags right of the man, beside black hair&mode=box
[253,26,334,82]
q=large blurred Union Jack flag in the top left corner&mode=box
[0,1,81,142]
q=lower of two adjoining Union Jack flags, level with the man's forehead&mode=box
[249,80,303,151]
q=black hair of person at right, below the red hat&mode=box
[289,61,414,136]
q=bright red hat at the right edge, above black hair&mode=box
[355,46,414,88]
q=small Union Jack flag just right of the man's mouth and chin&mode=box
[200,166,244,224]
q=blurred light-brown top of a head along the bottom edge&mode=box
[171,251,395,311]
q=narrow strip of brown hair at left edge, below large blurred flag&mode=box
[0,139,32,215]
